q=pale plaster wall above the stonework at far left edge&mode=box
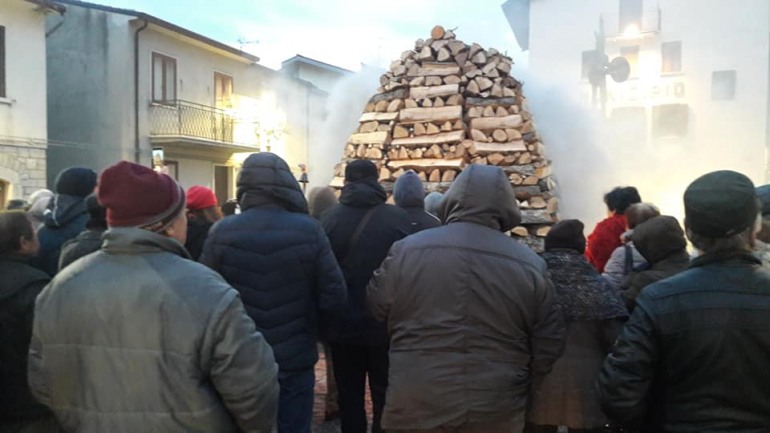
[0,0,46,140]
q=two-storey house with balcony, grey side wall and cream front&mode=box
[47,0,322,202]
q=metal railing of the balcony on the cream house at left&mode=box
[150,99,236,143]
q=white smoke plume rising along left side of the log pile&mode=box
[309,65,384,188]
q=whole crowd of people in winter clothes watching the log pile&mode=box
[0,152,770,433]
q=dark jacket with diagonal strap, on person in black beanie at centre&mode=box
[321,181,411,346]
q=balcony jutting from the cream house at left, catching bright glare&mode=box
[149,100,259,152]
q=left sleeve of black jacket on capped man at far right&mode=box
[599,292,658,425]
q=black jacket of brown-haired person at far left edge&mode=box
[0,257,51,424]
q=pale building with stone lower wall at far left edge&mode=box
[0,0,65,209]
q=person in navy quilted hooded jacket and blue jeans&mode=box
[201,152,347,433]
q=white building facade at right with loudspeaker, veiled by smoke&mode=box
[503,0,770,183]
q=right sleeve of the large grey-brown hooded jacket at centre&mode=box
[530,277,564,375]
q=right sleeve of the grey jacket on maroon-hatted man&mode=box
[206,290,279,433]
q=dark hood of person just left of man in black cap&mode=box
[631,215,687,264]
